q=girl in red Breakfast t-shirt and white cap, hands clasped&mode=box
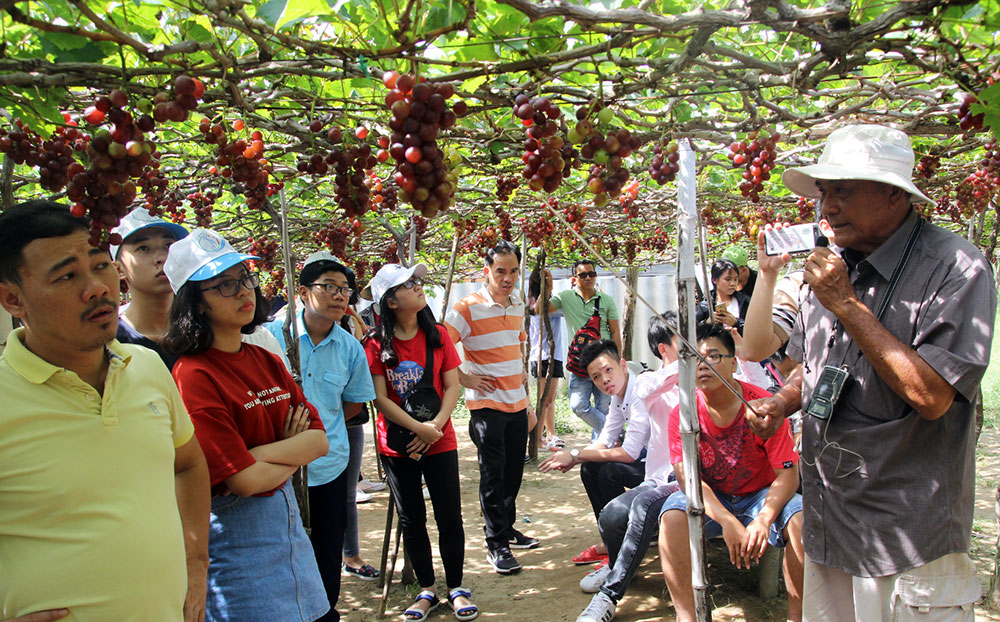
[365,264,479,620]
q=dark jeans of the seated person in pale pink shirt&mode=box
[598,482,677,603]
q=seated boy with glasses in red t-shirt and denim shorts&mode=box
[659,323,804,622]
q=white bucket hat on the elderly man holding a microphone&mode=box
[781,125,937,205]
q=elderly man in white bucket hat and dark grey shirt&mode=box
[747,125,996,622]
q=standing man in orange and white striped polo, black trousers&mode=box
[444,241,538,574]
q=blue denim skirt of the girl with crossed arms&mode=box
[205,479,330,622]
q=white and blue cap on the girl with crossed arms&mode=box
[163,229,260,294]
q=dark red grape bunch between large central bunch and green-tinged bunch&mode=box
[514,93,570,194]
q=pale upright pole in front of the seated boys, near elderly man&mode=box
[677,140,712,622]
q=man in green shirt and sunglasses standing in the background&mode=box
[535,259,622,441]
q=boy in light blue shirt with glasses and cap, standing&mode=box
[266,251,375,620]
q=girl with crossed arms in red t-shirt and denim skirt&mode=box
[164,229,330,622]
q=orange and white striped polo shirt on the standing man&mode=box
[444,284,528,412]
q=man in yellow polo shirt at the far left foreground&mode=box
[0,201,209,622]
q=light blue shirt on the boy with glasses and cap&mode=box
[265,311,375,486]
